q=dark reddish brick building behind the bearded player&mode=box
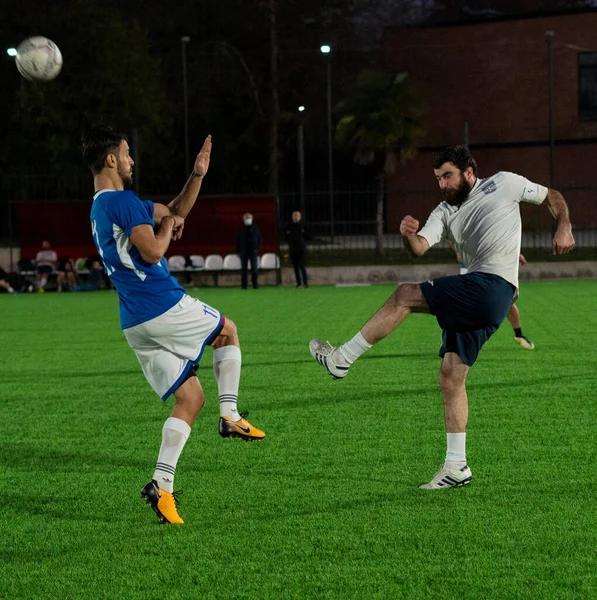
[383,11,597,232]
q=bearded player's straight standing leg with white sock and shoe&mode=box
[421,352,472,490]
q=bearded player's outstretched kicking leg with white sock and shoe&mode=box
[309,283,429,379]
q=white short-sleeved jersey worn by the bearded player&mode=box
[418,171,547,288]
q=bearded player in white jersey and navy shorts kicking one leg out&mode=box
[309,146,574,489]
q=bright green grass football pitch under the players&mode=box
[0,281,597,600]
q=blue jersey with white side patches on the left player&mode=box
[91,190,185,329]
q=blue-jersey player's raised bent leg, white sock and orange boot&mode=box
[212,319,265,441]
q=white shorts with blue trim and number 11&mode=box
[123,295,224,400]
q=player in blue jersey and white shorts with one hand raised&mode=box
[83,126,265,523]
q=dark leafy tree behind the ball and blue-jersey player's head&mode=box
[8,0,172,189]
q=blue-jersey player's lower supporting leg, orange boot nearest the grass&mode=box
[141,367,205,524]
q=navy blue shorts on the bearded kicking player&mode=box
[421,273,516,367]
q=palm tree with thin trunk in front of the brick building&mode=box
[335,69,424,256]
